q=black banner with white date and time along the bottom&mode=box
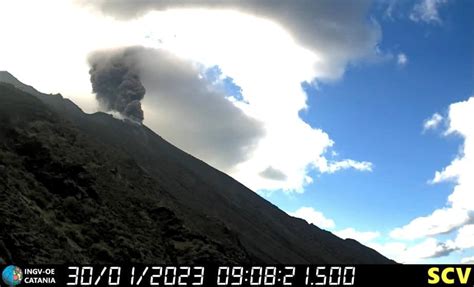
[0,264,474,287]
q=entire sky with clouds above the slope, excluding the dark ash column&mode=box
[0,0,474,263]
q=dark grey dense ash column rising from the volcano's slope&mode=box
[89,48,145,123]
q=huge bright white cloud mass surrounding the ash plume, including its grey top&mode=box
[0,0,381,194]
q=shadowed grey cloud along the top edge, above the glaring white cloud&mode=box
[76,0,381,78]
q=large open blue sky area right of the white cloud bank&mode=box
[265,1,474,262]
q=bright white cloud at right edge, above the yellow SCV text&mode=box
[390,97,474,243]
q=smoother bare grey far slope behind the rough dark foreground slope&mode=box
[0,72,393,264]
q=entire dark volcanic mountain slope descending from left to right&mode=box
[0,72,393,264]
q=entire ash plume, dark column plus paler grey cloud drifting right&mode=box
[89,47,264,171]
